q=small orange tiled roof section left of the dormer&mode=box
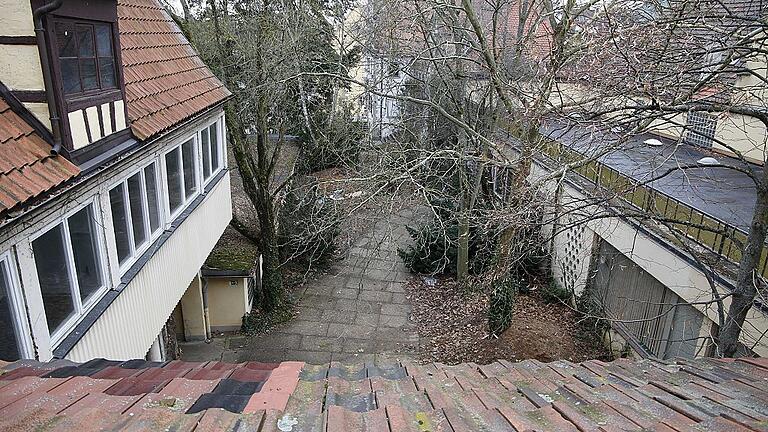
[0,97,80,215]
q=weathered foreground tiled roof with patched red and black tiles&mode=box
[0,359,768,432]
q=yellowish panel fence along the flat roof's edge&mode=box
[544,140,768,279]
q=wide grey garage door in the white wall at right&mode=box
[590,240,704,359]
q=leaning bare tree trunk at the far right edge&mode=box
[718,164,768,357]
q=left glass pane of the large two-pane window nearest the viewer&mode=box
[32,224,75,333]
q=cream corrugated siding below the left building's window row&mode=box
[67,174,232,362]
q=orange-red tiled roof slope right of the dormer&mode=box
[117,0,230,139]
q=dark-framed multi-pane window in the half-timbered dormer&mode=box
[54,19,117,98]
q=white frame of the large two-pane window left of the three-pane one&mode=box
[29,199,110,349]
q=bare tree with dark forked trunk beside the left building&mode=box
[178,0,356,312]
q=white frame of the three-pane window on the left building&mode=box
[107,159,166,277]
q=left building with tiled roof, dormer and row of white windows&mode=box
[0,0,231,361]
